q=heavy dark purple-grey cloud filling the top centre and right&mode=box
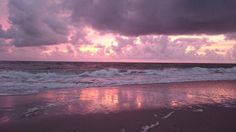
[67,0,236,35]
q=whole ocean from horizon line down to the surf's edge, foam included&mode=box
[0,61,236,95]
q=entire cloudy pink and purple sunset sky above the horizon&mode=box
[0,0,236,63]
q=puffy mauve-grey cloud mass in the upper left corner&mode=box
[0,0,68,47]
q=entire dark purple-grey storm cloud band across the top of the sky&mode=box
[0,0,236,46]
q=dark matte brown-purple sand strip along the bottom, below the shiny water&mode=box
[0,106,236,132]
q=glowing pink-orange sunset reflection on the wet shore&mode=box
[39,82,236,114]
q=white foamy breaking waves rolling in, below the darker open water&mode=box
[0,67,236,95]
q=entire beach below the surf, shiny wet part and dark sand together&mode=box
[0,81,236,132]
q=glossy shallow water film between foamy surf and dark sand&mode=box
[0,81,236,124]
